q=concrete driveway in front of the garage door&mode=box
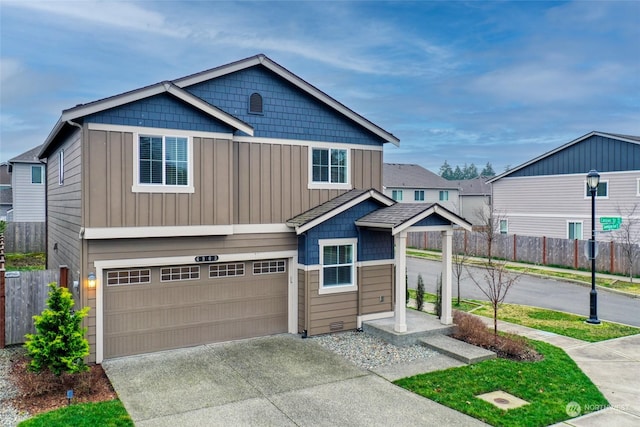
[103,335,485,427]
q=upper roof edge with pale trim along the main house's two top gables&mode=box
[39,54,400,157]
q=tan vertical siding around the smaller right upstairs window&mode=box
[233,142,382,224]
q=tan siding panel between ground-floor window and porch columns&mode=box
[359,264,394,314]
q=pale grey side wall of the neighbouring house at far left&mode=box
[11,163,46,222]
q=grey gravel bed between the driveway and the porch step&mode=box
[308,331,438,369]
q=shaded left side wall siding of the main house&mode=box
[47,130,82,290]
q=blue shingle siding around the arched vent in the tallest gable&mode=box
[184,66,384,146]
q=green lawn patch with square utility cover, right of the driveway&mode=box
[395,340,608,427]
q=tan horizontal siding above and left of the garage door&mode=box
[83,233,298,361]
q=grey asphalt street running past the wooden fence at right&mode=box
[407,257,640,326]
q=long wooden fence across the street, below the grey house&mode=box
[407,230,640,275]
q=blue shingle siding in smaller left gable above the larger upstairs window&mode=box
[85,93,234,133]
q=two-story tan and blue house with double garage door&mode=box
[40,55,470,363]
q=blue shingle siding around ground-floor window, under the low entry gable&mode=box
[298,200,393,265]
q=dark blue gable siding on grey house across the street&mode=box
[509,135,640,177]
